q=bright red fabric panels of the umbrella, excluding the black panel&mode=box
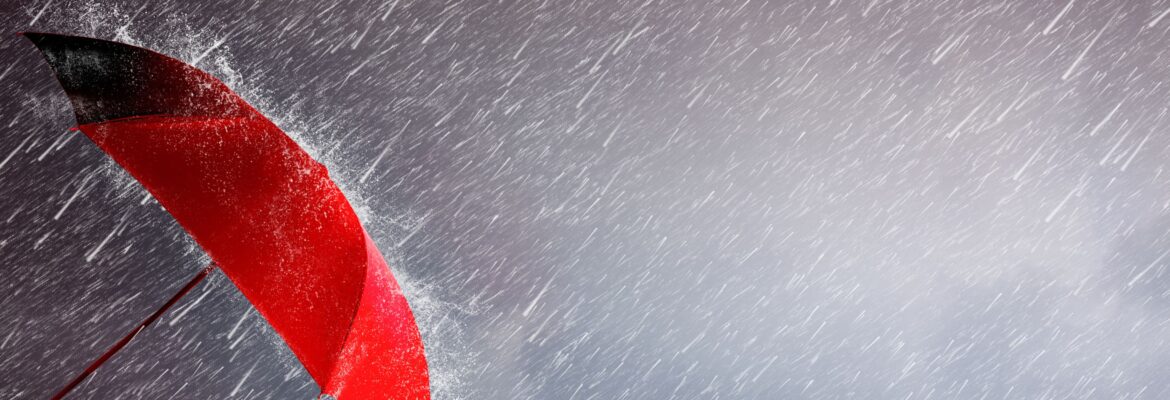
[81,115,429,400]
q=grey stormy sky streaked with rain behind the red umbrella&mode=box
[0,0,1170,399]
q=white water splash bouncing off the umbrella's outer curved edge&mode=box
[28,0,475,399]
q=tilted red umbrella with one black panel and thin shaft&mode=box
[25,33,429,400]
